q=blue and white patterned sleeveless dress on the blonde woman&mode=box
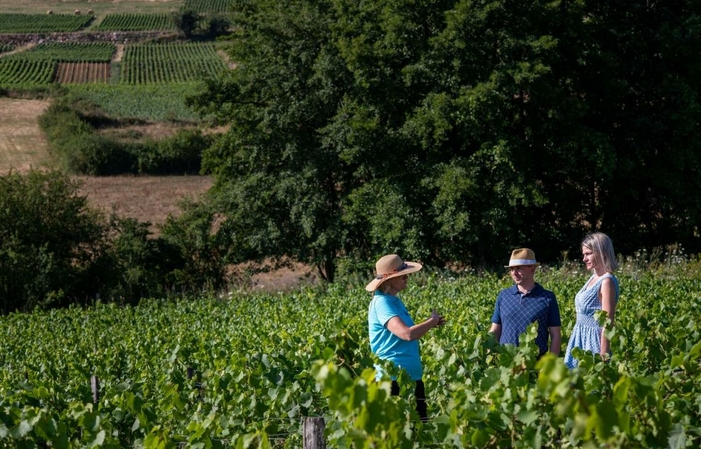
[565,273,618,369]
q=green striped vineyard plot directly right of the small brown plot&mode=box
[120,43,227,85]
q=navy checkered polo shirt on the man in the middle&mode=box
[492,283,560,355]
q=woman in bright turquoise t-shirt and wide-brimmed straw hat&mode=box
[365,254,445,421]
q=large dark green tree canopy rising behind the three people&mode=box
[192,0,701,279]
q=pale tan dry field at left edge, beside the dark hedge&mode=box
[0,98,50,174]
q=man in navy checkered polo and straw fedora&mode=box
[489,248,561,356]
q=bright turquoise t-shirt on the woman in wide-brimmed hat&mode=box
[368,290,423,380]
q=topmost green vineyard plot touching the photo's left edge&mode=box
[0,13,93,33]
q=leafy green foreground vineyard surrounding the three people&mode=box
[0,261,701,449]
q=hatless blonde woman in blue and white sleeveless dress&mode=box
[565,232,619,368]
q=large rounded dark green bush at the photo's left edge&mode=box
[0,171,106,314]
